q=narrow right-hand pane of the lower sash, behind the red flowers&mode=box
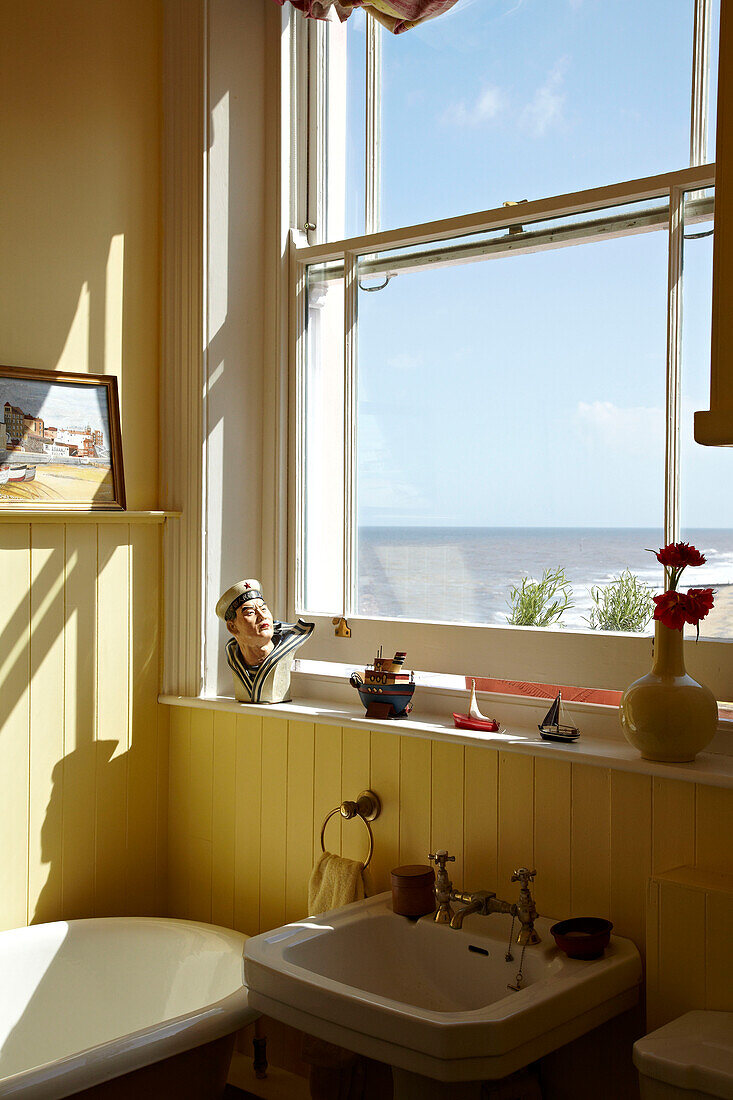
[680,196,733,638]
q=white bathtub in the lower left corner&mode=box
[0,917,258,1100]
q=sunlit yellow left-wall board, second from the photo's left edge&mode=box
[28,524,66,921]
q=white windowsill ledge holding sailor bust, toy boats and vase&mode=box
[158,673,733,788]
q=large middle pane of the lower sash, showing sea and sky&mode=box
[358,232,667,627]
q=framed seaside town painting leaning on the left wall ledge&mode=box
[0,366,125,512]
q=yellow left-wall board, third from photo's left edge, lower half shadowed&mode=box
[61,524,96,920]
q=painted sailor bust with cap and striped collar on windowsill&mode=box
[216,580,314,703]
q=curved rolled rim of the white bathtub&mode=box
[0,916,261,1100]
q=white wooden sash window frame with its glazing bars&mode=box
[280,0,733,700]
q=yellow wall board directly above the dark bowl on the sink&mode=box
[570,763,611,919]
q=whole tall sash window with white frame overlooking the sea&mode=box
[283,0,733,690]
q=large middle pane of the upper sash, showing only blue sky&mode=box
[374,0,693,228]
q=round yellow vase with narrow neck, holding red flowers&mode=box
[619,623,718,763]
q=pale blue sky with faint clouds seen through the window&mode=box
[319,0,733,527]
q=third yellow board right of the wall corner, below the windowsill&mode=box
[211,712,237,928]
